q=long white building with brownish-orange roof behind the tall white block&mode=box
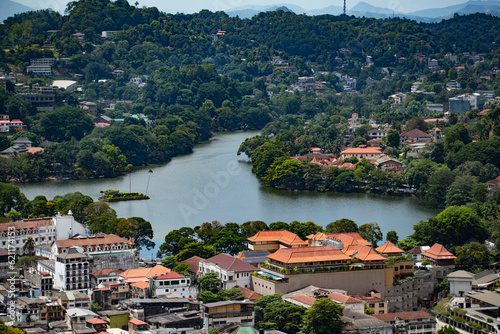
[52,233,137,272]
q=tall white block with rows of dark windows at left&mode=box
[54,247,92,291]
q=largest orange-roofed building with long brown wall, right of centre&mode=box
[252,244,385,295]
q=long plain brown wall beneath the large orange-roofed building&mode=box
[252,269,385,295]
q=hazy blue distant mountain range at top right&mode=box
[226,0,500,22]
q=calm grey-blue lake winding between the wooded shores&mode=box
[19,132,437,258]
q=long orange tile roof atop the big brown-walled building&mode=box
[268,246,351,263]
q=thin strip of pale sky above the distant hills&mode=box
[15,0,482,13]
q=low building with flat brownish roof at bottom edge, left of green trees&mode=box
[203,300,255,333]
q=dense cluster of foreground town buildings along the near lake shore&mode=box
[0,213,500,334]
